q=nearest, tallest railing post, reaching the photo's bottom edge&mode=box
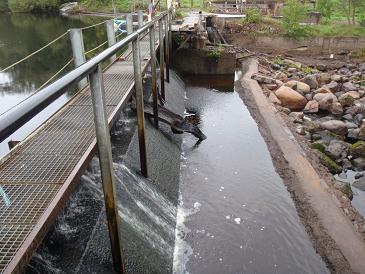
[90,65,125,273]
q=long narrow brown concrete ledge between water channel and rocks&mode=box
[238,60,365,273]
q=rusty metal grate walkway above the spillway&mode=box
[0,11,168,273]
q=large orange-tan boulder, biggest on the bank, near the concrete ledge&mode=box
[275,86,307,110]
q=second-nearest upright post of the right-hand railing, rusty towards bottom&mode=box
[132,37,148,177]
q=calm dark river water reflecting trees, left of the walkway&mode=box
[0,13,106,158]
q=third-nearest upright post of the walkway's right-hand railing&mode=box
[149,25,158,128]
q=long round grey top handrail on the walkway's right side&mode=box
[0,11,170,143]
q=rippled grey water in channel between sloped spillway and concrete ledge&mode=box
[174,76,328,273]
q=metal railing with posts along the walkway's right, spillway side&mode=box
[0,9,172,273]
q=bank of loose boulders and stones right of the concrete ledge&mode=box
[252,56,365,199]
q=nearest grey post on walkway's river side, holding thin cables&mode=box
[70,29,87,89]
